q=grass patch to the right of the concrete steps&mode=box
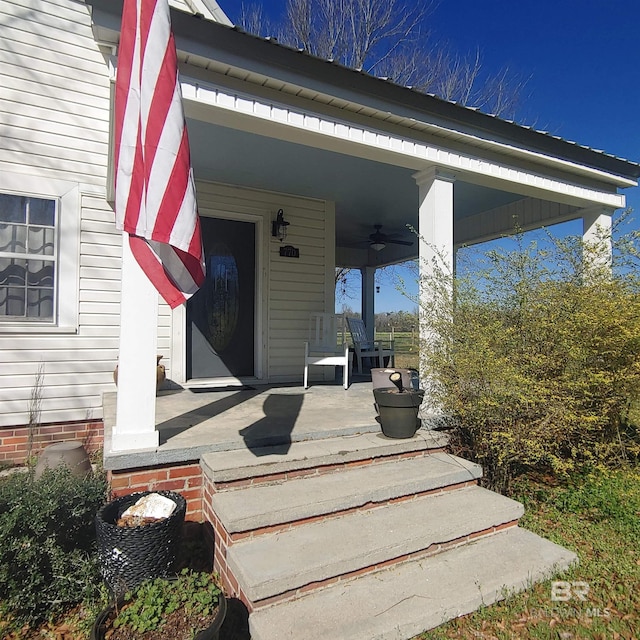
[414,467,640,640]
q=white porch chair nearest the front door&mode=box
[304,313,350,389]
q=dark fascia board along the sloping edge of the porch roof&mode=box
[164,14,640,179]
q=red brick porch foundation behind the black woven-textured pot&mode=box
[108,461,202,522]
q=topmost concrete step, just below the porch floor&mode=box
[201,429,449,484]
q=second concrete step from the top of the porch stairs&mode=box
[211,452,482,533]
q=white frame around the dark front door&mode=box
[170,207,270,388]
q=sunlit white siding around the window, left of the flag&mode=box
[0,0,116,426]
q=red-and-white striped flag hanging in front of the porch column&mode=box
[115,0,204,308]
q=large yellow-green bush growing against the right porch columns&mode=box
[421,218,640,491]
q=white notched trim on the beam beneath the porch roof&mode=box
[181,77,636,209]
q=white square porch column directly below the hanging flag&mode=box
[111,233,159,451]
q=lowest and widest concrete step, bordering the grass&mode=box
[249,527,576,640]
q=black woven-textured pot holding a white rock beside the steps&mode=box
[96,491,187,595]
